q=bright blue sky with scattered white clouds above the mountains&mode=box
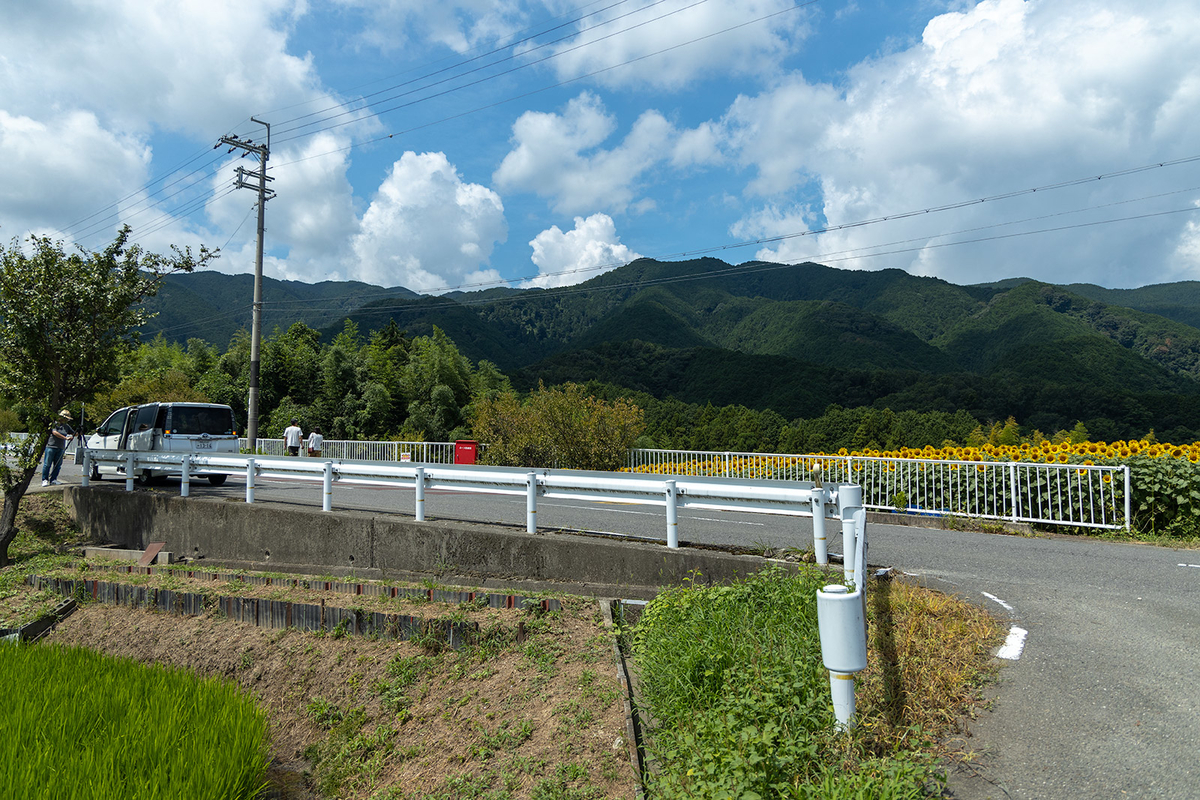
[0,0,1200,293]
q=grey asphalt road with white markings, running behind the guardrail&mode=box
[44,465,1200,800]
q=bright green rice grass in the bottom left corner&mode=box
[0,645,269,800]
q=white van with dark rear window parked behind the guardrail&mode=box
[88,403,238,486]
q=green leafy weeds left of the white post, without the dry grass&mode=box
[634,567,955,800]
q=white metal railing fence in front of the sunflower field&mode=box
[629,450,1132,530]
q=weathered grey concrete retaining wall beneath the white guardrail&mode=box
[64,486,787,597]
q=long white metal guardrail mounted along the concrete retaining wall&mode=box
[83,450,864,556]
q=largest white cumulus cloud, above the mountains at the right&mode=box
[722,0,1200,285]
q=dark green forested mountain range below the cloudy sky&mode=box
[145,258,1200,440]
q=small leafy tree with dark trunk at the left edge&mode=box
[0,227,216,566]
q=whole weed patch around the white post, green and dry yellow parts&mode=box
[632,567,997,800]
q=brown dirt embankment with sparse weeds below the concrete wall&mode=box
[50,576,636,800]
